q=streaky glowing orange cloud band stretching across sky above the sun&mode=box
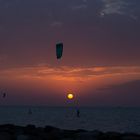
[0,66,140,82]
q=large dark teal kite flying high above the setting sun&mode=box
[56,43,63,59]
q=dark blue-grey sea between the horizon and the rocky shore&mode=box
[0,106,140,133]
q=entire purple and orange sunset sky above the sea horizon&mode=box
[0,0,140,106]
